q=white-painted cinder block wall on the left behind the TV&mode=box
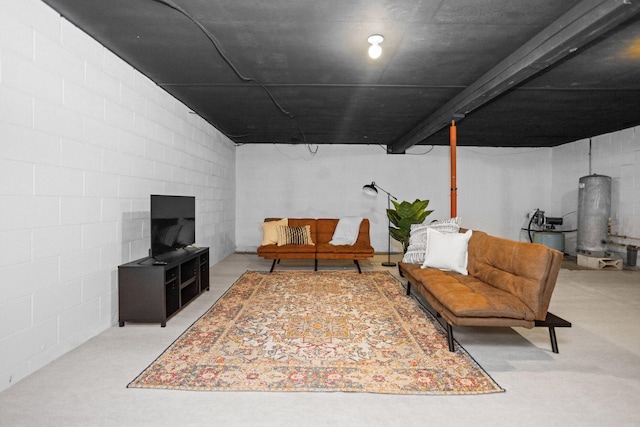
[0,0,236,390]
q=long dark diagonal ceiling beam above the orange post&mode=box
[387,0,640,154]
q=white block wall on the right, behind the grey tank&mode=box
[552,127,640,257]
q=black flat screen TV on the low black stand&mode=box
[151,194,196,258]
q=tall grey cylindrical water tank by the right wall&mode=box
[576,174,611,254]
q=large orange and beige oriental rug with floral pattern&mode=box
[127,271,504,395]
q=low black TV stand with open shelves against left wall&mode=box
[118,248,209,327]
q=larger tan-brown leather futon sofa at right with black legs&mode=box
[399,230,571,353]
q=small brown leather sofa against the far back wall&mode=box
[257,218,373,273]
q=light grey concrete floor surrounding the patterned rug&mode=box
[0,254,640,427]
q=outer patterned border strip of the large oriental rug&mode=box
[126,270,506,396]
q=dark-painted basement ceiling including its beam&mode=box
[44,0,640,153]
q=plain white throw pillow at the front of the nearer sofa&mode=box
[422,229,472,276]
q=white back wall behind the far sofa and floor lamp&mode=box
[236,144,551,252]
